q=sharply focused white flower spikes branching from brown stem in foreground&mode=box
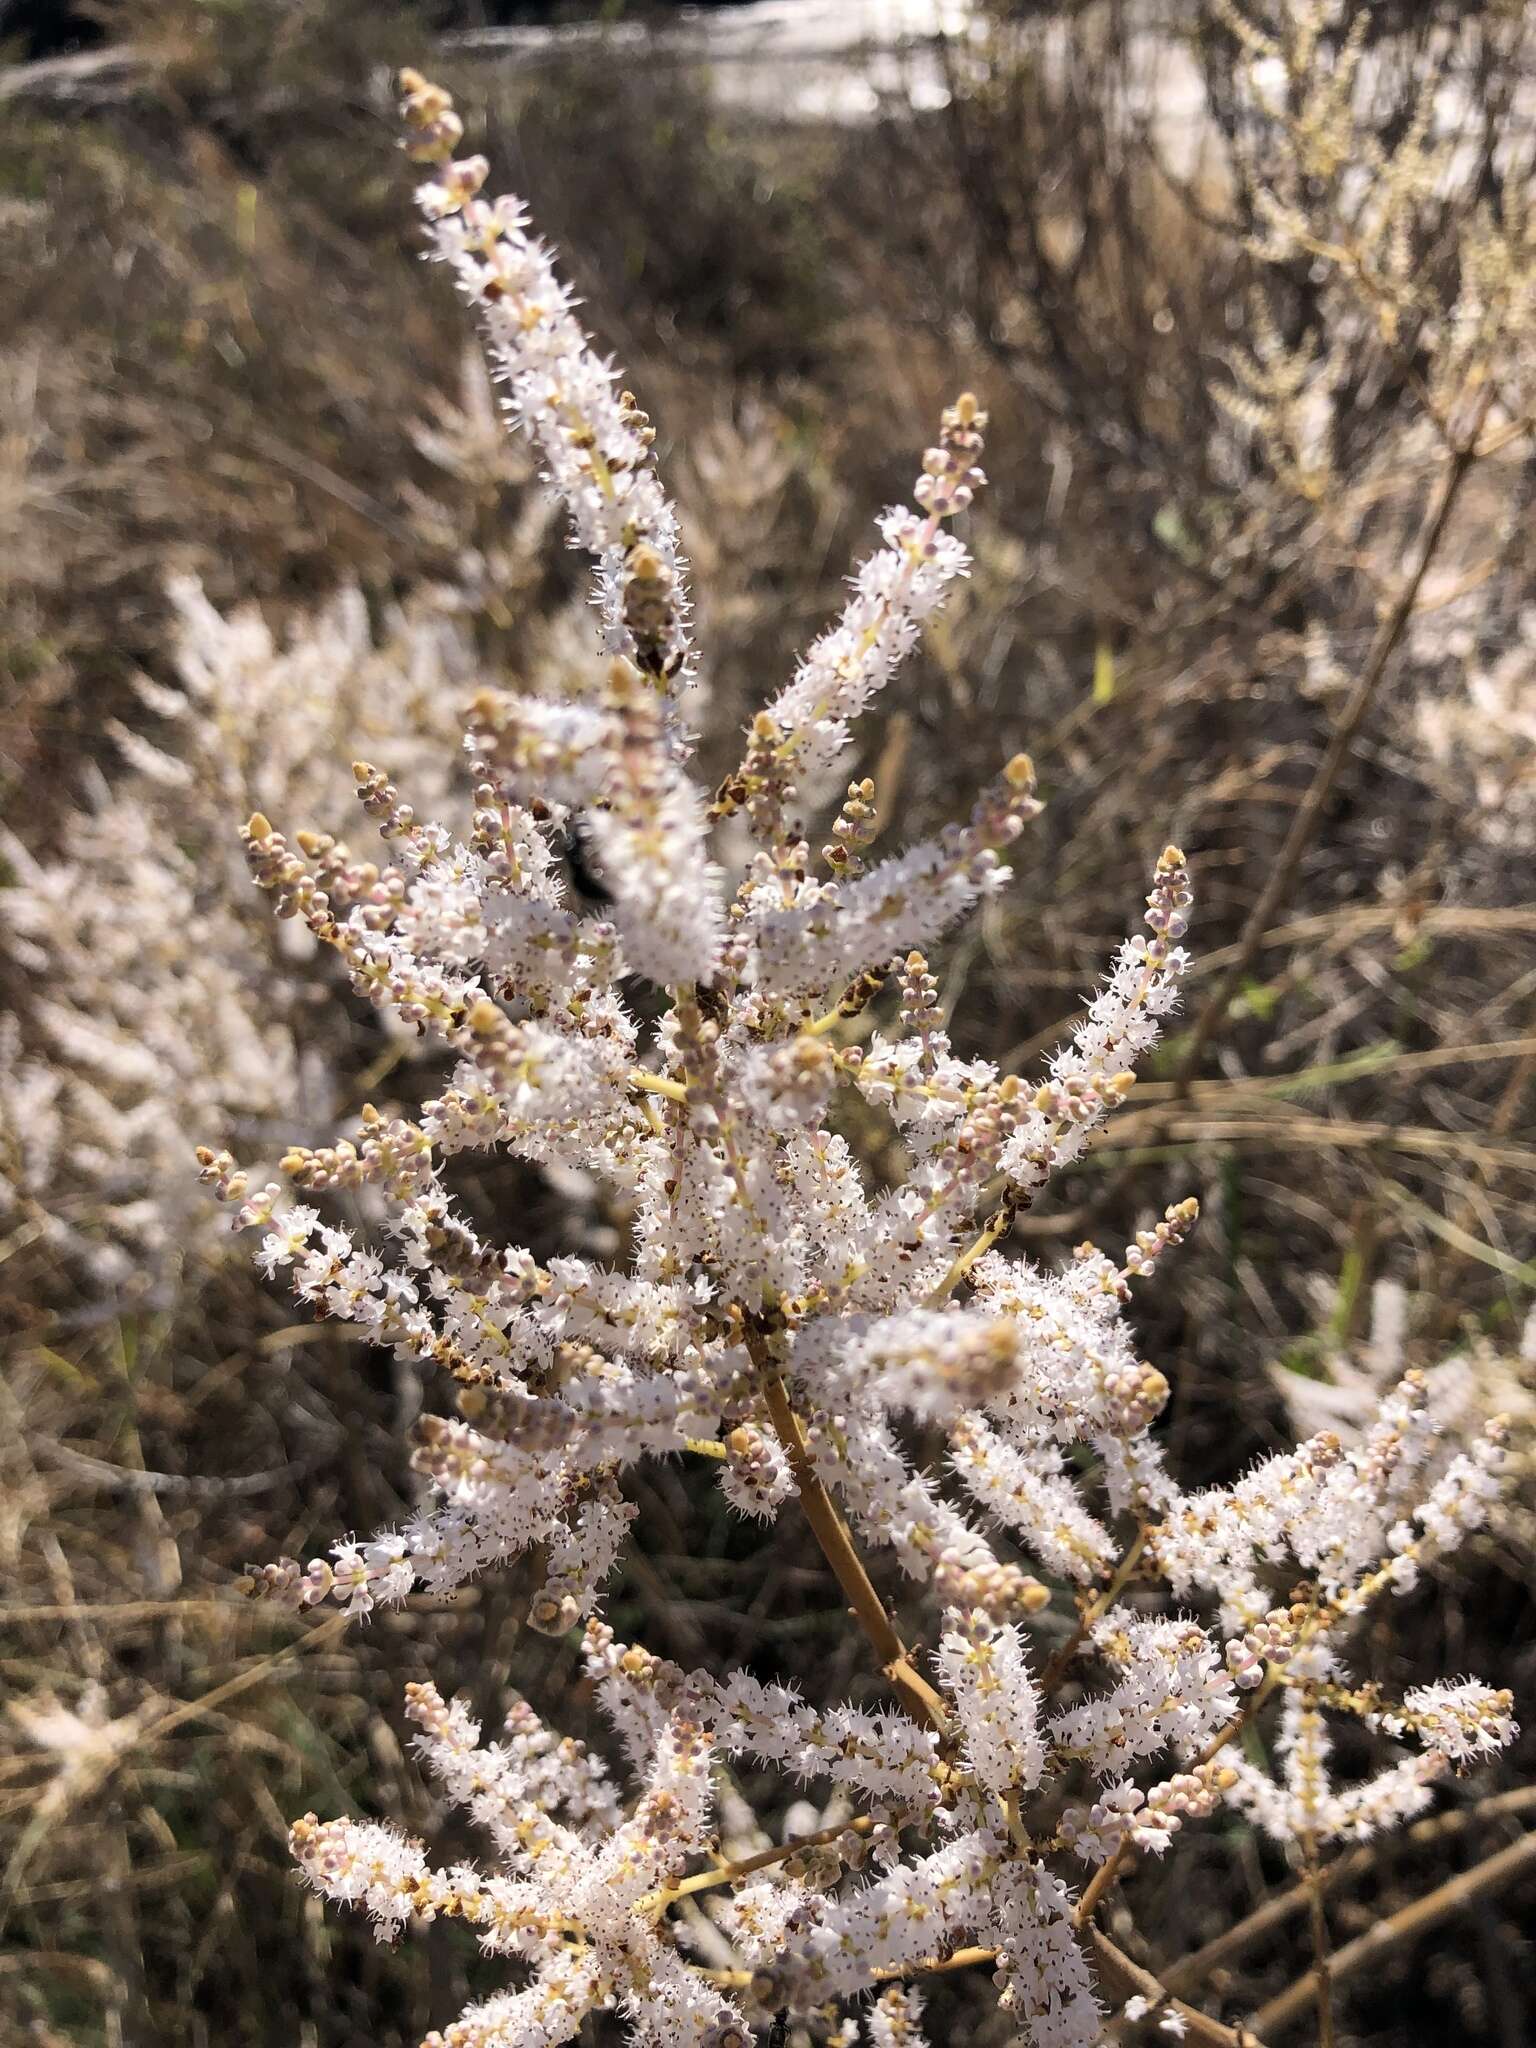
[203,74,1513,2048]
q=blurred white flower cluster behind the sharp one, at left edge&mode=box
[0,580,473,1305]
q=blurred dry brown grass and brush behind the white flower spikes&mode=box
[0,0,1536,2048]
